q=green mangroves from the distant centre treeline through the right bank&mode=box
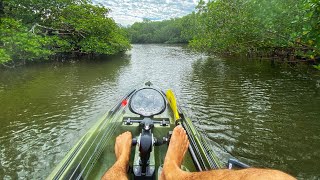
[128,0,320,64]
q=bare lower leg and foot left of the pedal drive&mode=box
[101,131,132,180]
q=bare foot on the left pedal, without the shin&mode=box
[114,131,132,161]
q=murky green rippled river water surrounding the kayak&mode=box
[0,45,320,179]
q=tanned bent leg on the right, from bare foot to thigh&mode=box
[161,126,295,180]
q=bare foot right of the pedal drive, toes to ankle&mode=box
[161,125,189,179]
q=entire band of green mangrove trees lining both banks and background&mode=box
[0,0,320,68]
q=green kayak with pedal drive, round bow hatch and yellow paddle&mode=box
[47,83,226,179]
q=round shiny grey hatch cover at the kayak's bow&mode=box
[130,88,166,116]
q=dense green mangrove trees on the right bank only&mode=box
[190,0,320,59]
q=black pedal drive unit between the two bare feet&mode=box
[125,117,172,179]
